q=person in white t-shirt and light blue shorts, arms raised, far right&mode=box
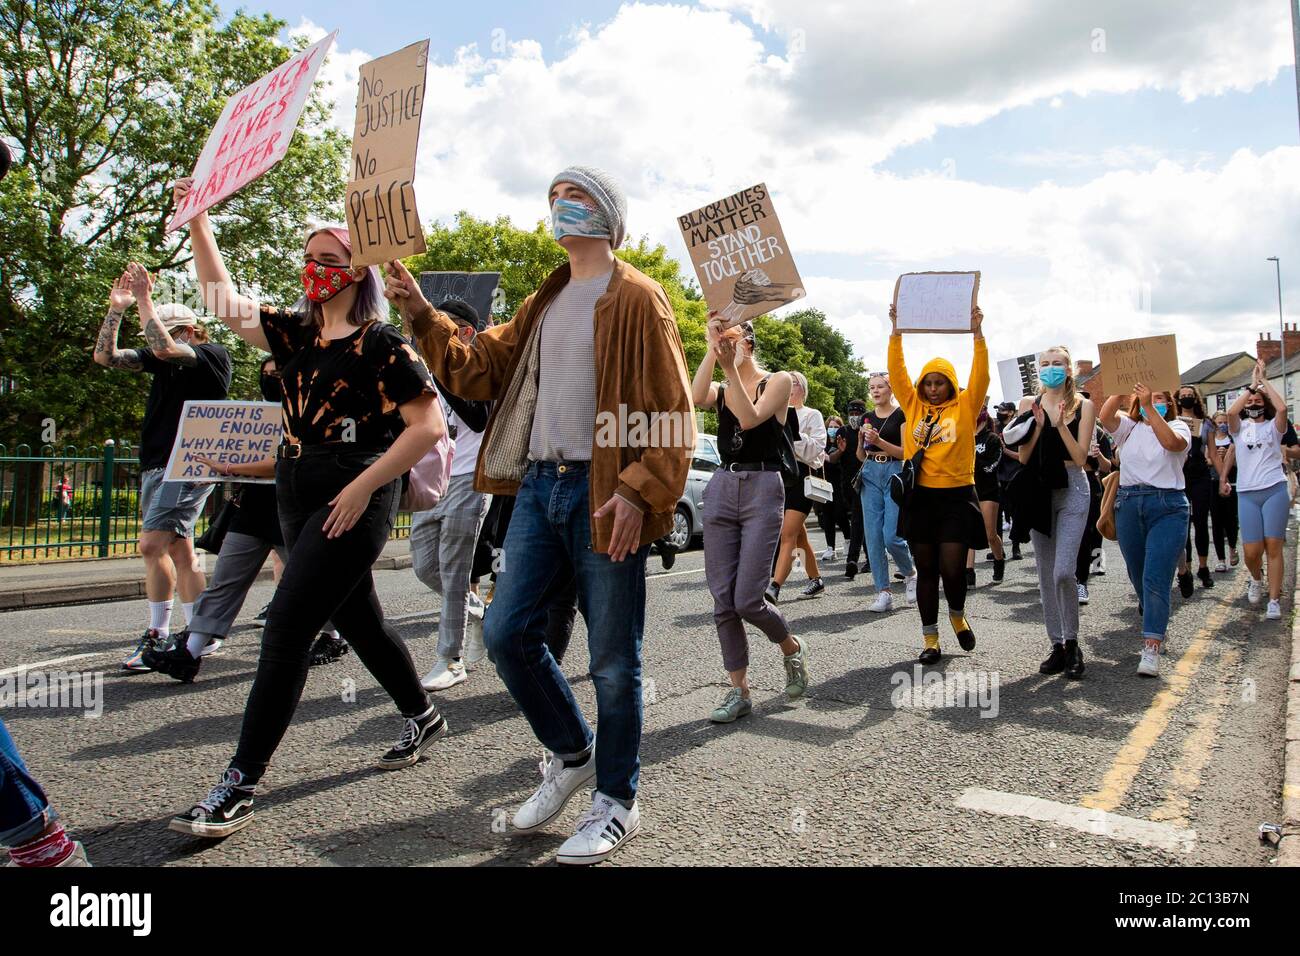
[1227,360,1291,620]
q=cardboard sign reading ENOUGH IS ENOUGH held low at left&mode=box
[163,402,283,484]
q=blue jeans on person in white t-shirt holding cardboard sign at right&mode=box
[1115,485,1191,641]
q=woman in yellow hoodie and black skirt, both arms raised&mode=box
[889,307,988,663]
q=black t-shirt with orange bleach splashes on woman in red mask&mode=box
[261,308,436,449]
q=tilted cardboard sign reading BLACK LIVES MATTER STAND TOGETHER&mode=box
[677,182,805,328]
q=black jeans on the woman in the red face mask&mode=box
[230,449,429,783]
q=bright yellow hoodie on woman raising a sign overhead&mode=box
[889,334,988,488]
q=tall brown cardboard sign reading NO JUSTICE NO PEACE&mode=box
[346,40,429,268]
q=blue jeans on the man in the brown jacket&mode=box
[484,462,650,803]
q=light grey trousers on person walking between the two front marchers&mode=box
[411,473,488,659]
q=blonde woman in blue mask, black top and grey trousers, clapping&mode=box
[1013,346,1097,679]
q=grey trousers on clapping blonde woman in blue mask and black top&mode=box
[1030,464,1089,644]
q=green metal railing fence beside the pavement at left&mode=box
[0,441,411,563]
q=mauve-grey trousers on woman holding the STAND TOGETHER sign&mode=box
[703,470,790,672]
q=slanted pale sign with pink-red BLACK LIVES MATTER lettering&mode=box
[166,30,338,232]
